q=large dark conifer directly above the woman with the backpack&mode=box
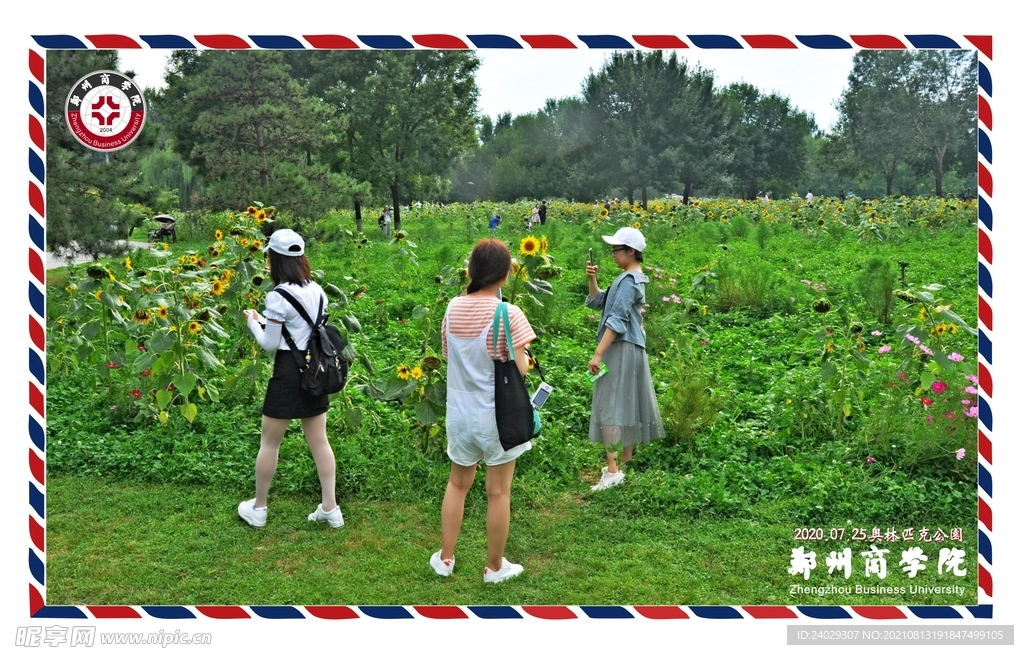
[154,50,355,217]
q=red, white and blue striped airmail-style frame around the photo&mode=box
[28,34,994,621]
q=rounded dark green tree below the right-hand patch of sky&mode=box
[723,82,815,199]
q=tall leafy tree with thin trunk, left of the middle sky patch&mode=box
[308,50,479,230]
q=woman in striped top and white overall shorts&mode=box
[430,238,537,582]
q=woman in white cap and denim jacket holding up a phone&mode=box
[587,227,665,491]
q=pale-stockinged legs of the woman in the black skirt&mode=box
[254,413,338,512]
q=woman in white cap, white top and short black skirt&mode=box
[239,229,345,528]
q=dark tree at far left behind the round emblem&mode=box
[46,50,157,259]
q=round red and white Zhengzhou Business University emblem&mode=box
[65,71,145,152]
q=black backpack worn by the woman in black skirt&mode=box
[273,287,348,396]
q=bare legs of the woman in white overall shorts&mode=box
[441,460,515,571]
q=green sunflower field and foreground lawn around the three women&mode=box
[46,199,978,605]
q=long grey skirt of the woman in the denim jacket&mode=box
[590,341,665,446]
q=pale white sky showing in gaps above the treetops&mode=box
[120,48,853,130]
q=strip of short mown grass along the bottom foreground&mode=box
[46,473,977,605]
